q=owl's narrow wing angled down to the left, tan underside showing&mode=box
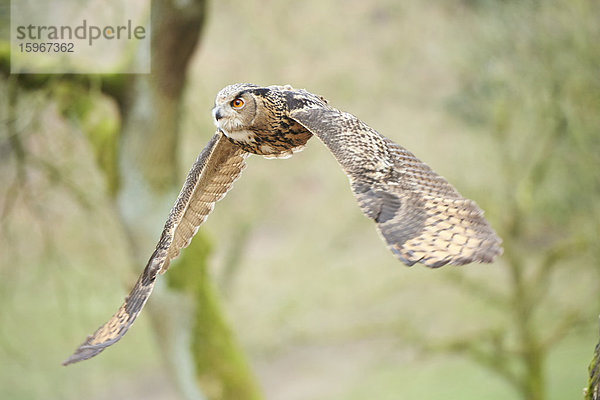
[63,131,248,365]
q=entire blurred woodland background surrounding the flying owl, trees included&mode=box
[0,0,600,400]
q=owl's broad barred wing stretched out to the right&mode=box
[290,106,502,267]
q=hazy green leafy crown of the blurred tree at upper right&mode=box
[451,0,600,229]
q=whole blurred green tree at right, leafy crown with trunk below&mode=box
[450,0,600,399]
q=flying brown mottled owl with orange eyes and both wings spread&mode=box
[63,83,502,365]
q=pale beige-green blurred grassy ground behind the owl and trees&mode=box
[0,0,598,400]
